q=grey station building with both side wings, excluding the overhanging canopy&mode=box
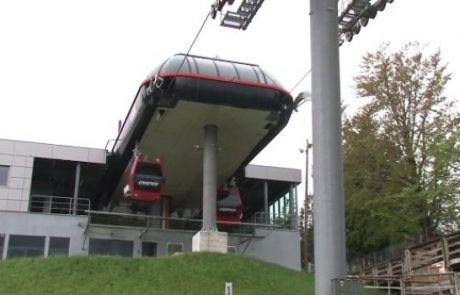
[0,139,301,270]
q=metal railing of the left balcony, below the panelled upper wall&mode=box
[29,195,91,215]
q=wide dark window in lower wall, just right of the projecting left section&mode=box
[89,239,134,257]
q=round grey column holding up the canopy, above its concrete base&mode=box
[202,125,217,231]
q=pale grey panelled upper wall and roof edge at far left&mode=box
[0,139,106,212]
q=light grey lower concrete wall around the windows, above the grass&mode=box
[0,211,300,270]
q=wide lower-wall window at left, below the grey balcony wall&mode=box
[7,235,45,258]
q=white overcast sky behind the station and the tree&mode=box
[0,0,460,203]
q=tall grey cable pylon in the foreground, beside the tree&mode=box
[310,0,346,295]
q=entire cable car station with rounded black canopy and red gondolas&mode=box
[0,54,301,270]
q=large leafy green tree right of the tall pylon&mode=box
[343,43,460,253]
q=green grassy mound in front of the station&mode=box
[0,253,381,295]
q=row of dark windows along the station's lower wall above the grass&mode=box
[0,234,184,258]
